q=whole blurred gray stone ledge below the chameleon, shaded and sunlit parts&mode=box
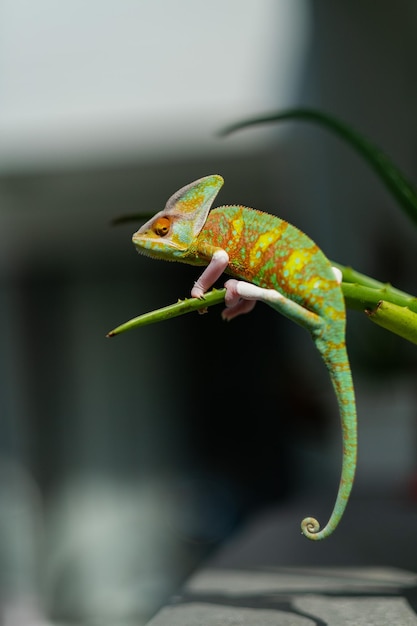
[144,499,417,626]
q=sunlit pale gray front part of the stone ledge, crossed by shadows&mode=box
[148,567,417,626]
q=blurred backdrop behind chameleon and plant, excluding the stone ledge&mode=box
[0,0,417,625]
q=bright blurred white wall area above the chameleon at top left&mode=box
[0,0,308,171]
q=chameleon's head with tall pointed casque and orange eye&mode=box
[132,174,223,261]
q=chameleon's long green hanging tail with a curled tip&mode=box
[301,340,357,541]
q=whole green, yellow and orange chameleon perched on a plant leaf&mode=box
[132,174,357,540]
